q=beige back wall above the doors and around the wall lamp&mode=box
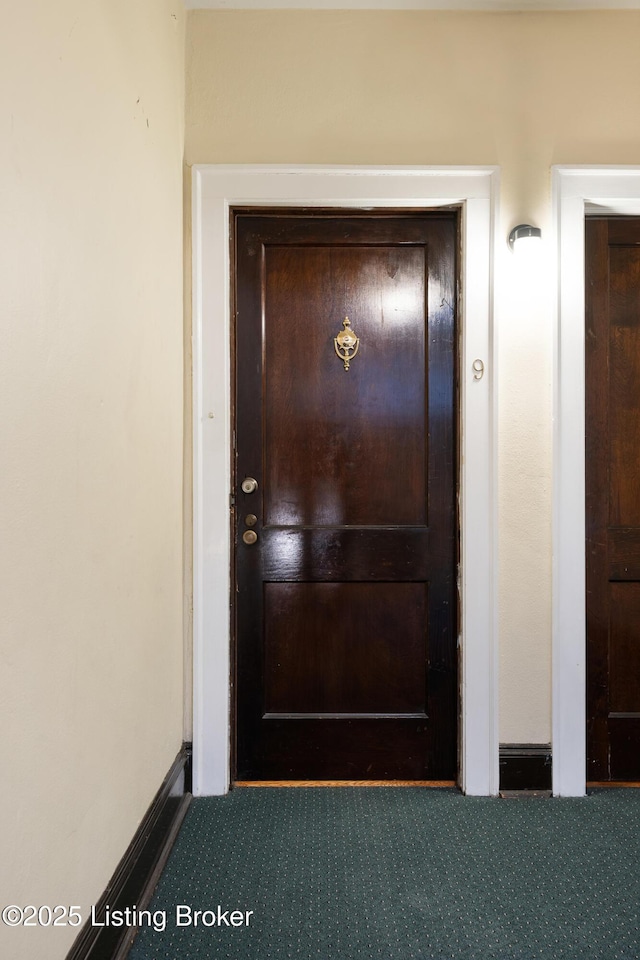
[185,11,640,742]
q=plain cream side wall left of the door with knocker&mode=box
[0,0,185,960]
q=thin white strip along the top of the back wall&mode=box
[185,0,640,13]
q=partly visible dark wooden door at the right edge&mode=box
[585,218,640,780]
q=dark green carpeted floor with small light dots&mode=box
[129,787,640,960]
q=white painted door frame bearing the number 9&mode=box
[193,165,498,796]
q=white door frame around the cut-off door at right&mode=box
[552,166,640,797]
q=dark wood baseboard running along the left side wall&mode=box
[67,744,191,960]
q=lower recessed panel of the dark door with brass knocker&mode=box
[265,583,428,717]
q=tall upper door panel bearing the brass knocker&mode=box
[265,245,426,526]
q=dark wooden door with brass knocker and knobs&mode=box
[235,211,457,779]
